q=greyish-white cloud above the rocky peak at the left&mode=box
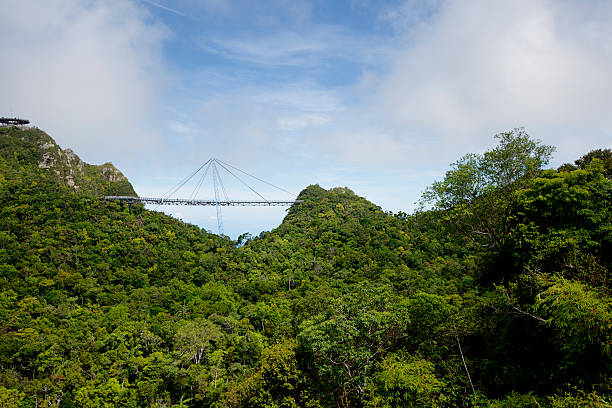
[0,0,167,166]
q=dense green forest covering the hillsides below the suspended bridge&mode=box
[0,128,612,408]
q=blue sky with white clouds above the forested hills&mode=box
[0,0,612,237]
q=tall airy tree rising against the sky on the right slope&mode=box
[423,128,555,249]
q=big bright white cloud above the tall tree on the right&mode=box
[373,0,612,160]
